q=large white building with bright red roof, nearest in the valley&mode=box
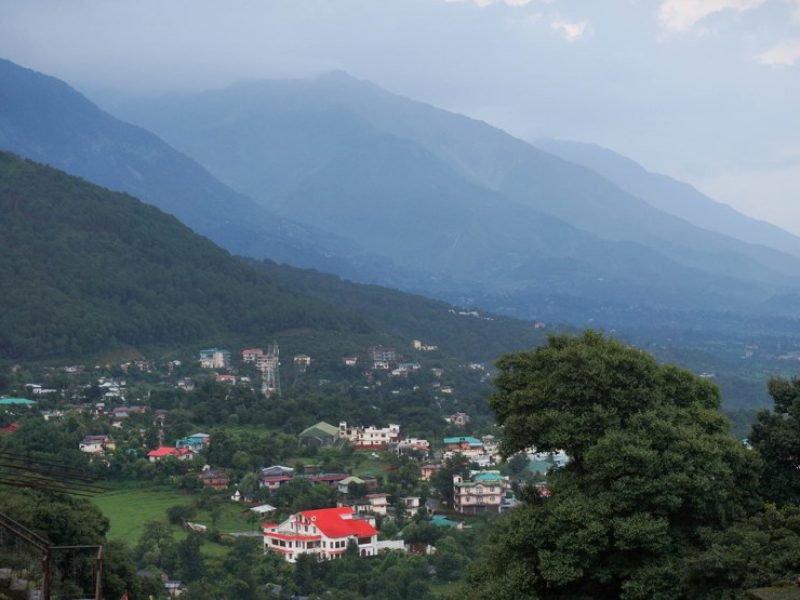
[261,506,379,562]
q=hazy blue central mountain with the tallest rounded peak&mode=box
[115,73,800,316]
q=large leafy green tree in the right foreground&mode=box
[470,332,759,599]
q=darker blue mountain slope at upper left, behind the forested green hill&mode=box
[0,59,366,270]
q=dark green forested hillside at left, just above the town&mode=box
[0,152,542,360]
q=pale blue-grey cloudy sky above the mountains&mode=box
[0,0,800,234]
